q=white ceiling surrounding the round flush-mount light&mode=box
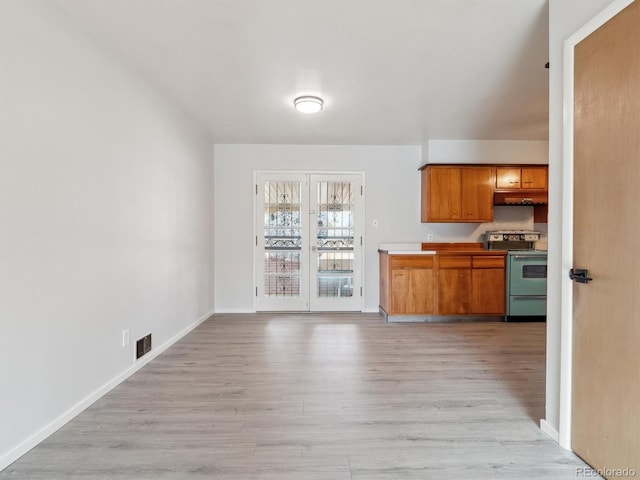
[59,0,548,145]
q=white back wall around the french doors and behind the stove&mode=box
[215,142,546,312]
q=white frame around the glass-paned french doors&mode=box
[251,170,367,312]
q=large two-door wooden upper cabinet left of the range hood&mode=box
[421,165,495,223]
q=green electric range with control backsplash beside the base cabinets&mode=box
[486,230,547,320]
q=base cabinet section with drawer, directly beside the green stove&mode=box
[471,255,506,315]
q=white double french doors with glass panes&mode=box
[254,172,364,311]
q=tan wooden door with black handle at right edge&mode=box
[571,2,640,478]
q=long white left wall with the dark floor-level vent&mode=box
[0,0,213,469]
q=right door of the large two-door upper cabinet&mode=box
[461,167,493,222]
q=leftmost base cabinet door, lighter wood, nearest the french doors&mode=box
[389,268,435,315]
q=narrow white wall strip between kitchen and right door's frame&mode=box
[545,0,611,447]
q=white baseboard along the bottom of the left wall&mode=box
[0,310,214,471]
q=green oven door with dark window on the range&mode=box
[509,253,547,296]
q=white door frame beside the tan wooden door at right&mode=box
[547,0,634,450]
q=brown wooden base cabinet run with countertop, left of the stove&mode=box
[378,242,507,322]
